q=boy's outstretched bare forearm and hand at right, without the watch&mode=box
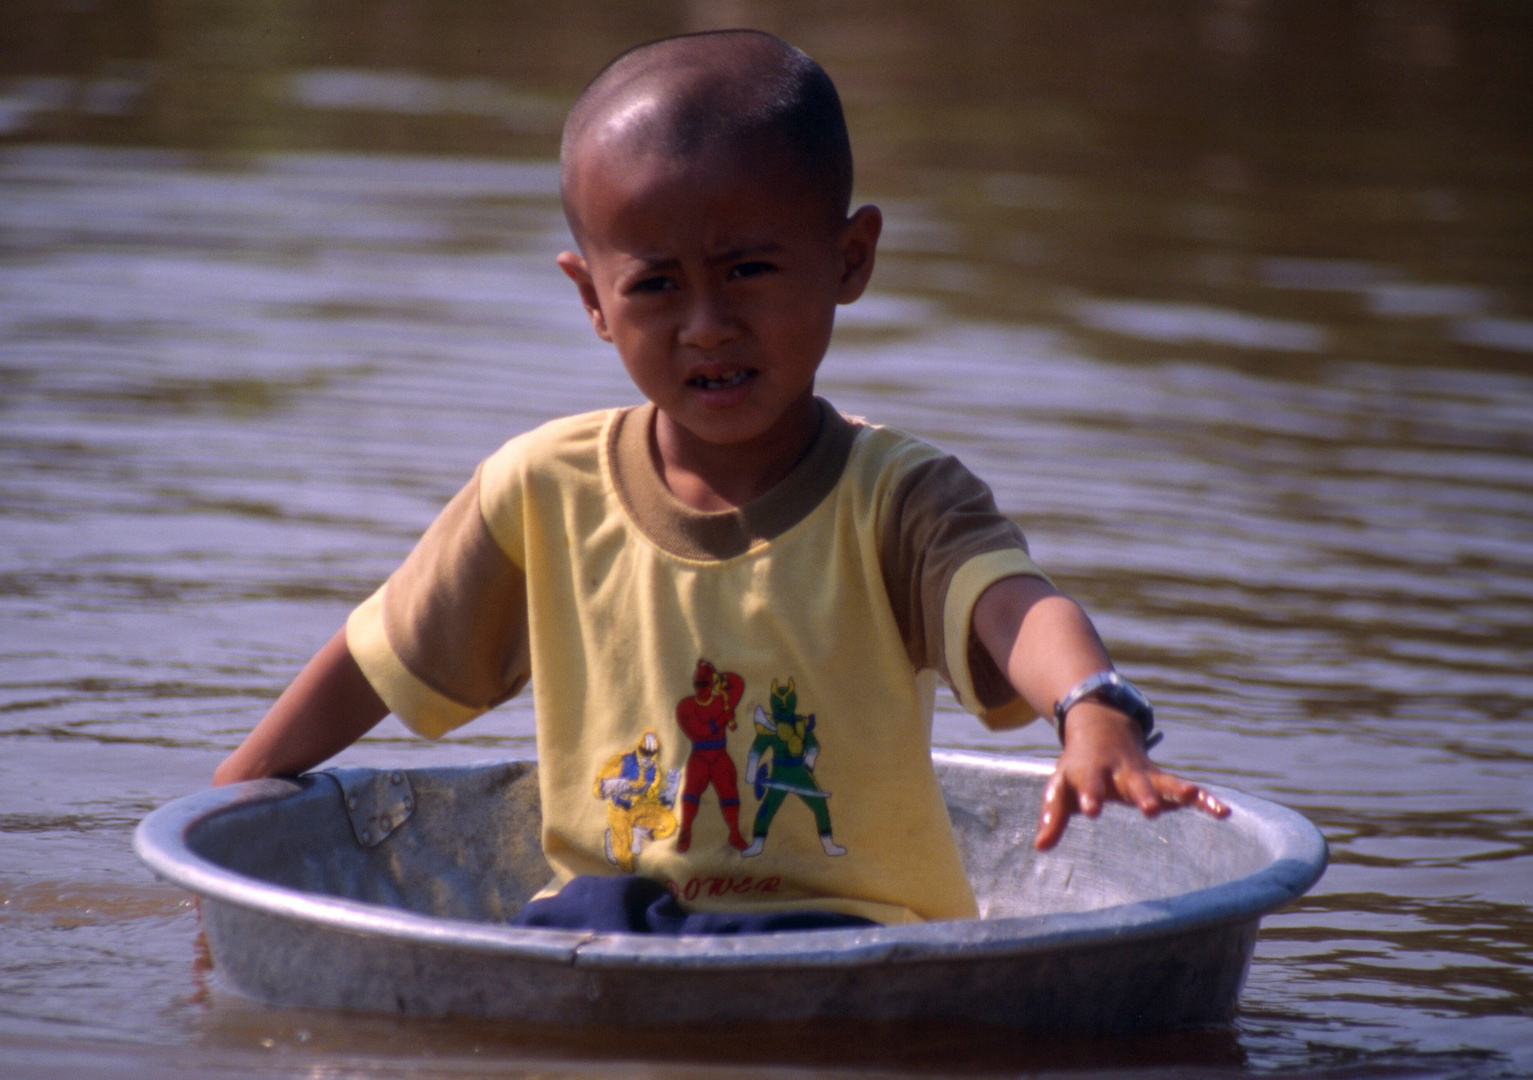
[973,576,1229,852]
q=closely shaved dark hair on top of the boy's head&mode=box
[560,31,852,241]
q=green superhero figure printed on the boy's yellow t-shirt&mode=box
[740,679,846,858]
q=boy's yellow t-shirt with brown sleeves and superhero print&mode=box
[346,401,1041,922]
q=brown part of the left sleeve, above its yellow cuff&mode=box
[382,466,530,711]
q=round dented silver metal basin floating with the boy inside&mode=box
[133,752,1326,1031]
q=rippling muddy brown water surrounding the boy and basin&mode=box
[0,0,1533,1078]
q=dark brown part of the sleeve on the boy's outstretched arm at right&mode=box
[880,455,1048,711]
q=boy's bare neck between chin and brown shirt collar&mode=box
[650,394,823,513]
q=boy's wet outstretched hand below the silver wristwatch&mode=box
[1033,702,1229,852]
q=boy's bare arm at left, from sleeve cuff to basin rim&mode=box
[213,627,388,786]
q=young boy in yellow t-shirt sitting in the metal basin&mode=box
[215,31,1228,930]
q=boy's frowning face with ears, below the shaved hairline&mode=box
[560,137,881,444]
